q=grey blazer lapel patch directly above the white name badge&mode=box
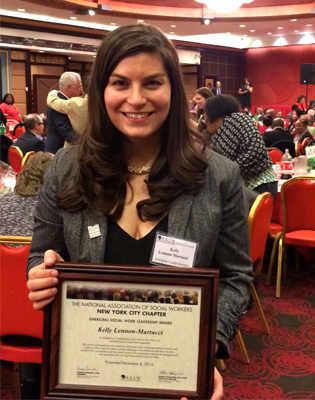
[168,194,194,238]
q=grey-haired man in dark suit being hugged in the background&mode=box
[45,72,83,154]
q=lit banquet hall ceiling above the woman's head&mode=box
[0,0,315,57]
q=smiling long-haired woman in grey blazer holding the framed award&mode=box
[27,24,252,400]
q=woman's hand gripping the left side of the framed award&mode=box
[27,250,64,310]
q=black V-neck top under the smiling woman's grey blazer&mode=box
[104,215,168,265]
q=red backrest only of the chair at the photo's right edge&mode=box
[281,176,315,236]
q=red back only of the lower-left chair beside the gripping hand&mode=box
[0,236,43,339]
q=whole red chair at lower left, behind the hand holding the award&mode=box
[0,236,43,397]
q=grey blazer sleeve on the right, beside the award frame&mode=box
[212,164,253,358]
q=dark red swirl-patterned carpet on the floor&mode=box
[0,248,315,400]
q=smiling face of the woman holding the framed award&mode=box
[104,53,171,143]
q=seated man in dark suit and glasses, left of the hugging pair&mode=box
[14,114,45,154]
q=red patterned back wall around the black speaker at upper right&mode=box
[246,44,315,106]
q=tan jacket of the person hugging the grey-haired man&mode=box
[47,90,88,143]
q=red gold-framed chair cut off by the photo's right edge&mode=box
[276,176,315,298]
